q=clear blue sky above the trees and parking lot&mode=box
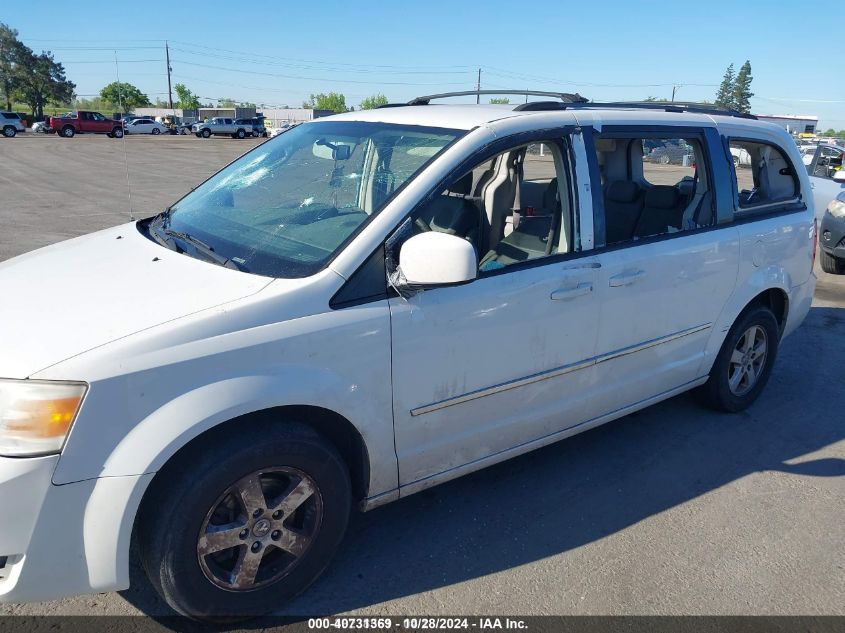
[6,0,845,130]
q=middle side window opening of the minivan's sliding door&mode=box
[595,130,715,245]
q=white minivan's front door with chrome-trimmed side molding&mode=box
[389,131,599,487]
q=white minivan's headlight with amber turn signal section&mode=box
[0,380,88,457]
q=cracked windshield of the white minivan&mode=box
[166,121,462,277]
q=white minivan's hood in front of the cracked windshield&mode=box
[0,223,272,378]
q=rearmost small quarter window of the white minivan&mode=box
[730,139,798,211]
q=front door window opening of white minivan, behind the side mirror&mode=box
[412,141,576,273]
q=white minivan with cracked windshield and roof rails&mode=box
[0,93,816,618]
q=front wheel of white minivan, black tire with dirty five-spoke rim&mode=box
[138,423,352,620]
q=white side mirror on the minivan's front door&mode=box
[399,231,478,289]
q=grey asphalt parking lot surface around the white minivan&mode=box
[0,134,845,615]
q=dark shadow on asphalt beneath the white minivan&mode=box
[122,308,845,616]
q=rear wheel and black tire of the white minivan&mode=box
[699,304,780,413]
